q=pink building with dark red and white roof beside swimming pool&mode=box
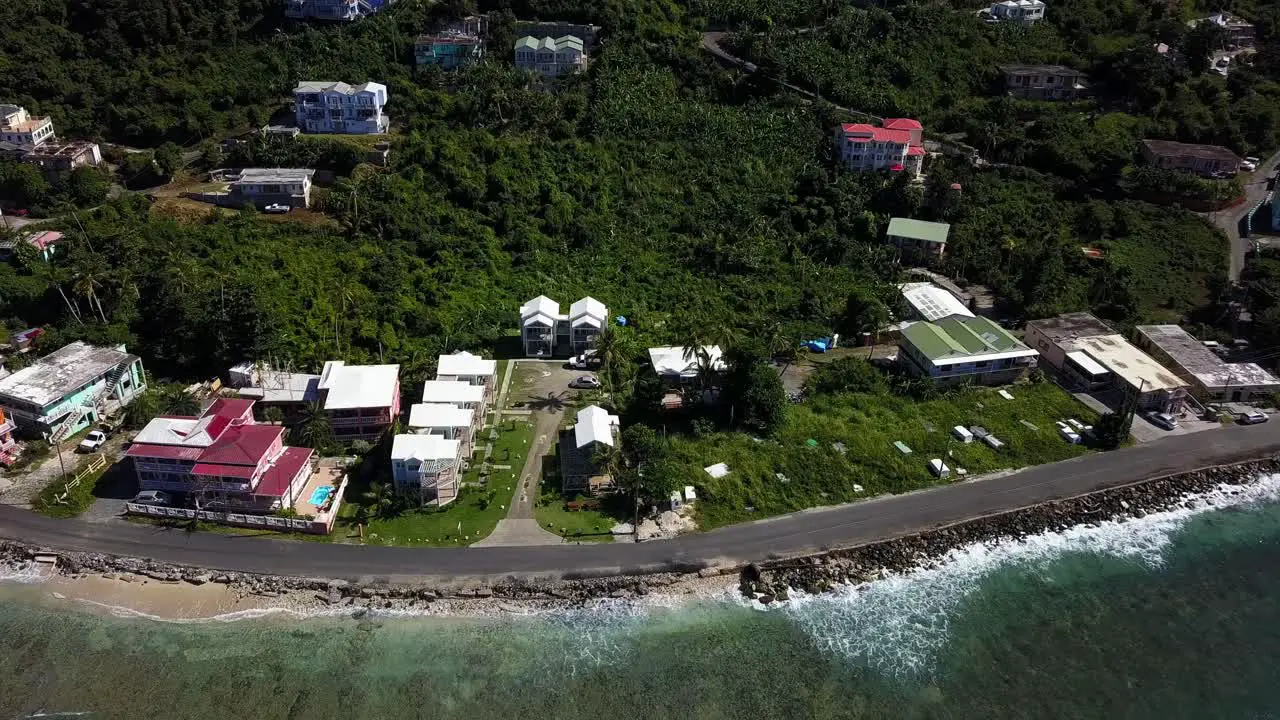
[124,397,314,512]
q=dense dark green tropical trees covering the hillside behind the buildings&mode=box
[0,0,1280,520]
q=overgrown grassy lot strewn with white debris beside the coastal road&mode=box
[672,383,1097,529]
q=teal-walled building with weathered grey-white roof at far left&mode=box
[0,342,146,437]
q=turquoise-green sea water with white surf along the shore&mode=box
[0,478,1280,720]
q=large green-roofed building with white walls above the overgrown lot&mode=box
[899,315,1039,386]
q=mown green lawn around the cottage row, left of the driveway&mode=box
[334,418,534,547]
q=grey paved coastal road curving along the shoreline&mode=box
[0,421,1280,582]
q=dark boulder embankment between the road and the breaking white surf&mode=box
[739,457,1280,605]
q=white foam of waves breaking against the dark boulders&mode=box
[750,475,1280,675]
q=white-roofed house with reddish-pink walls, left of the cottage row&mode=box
[316,360,399,443]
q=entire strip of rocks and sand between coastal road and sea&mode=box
[0,459,1280,616]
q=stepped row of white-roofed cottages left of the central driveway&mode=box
[392,352,498,505]
